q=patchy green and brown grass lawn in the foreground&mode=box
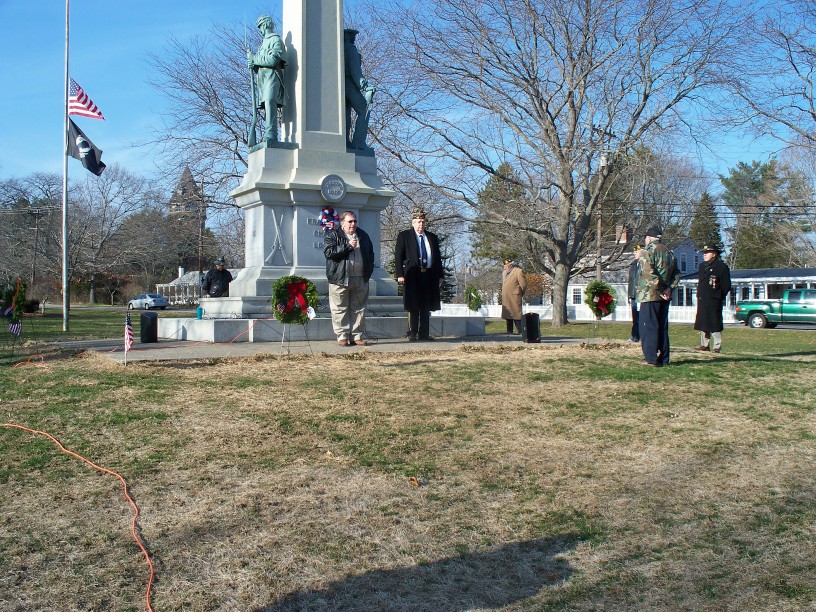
[0,309,816,611]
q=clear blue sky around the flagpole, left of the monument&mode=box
[0,0,281,179]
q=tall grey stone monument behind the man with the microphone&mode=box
[159,0,484,342]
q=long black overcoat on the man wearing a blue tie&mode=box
[394,229,445,311]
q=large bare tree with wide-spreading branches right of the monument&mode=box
[366,0,741,326]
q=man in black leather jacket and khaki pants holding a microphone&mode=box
[323,210,374,346]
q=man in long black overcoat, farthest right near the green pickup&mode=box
[694,244,731,353]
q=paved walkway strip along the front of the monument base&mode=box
[56,334,583,363]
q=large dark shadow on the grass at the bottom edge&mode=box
[258,534,579,612]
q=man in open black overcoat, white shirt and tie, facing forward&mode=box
[394,209,445,341]
